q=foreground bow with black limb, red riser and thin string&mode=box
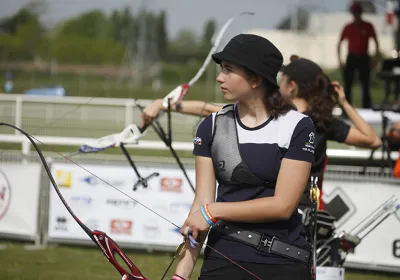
[0,122,262,280]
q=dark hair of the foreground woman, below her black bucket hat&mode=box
[244,67,297,118]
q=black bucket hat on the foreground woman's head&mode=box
[212,34,283,89]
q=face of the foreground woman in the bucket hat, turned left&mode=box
[217,61,253,101]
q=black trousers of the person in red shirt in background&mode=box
[343,53,371,108]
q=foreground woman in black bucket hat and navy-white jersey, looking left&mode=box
[169,34,315,280]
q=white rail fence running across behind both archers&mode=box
[0,94,400,162]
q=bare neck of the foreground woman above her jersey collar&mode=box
[238,96,269,127]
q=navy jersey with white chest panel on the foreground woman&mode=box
[193,105,315,264]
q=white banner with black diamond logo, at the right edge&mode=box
[323,179,400,269]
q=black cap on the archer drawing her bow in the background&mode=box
[281,58,323,86]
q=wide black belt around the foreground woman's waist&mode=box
[212,221,311,266]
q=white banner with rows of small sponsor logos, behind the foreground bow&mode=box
[48,163,195,246]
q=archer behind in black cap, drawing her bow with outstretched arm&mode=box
[142,55,382,209]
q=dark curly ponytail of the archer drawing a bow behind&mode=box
[288,72,338,132]
